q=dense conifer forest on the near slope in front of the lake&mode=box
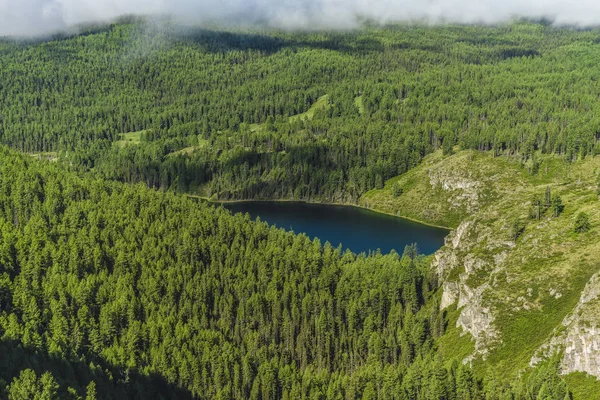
[0,149,568,400]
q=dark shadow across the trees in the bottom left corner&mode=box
[0,340,193,400]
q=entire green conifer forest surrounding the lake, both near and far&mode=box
[0,19,600,400]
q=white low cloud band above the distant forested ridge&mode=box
[0,0,600,37]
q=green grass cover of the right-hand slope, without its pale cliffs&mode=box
[361,151,600,398]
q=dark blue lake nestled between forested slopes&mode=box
[222,201,449,254]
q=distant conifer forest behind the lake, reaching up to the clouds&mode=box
[0,20,600,202]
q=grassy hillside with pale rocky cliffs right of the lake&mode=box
[361,151,600,399]
